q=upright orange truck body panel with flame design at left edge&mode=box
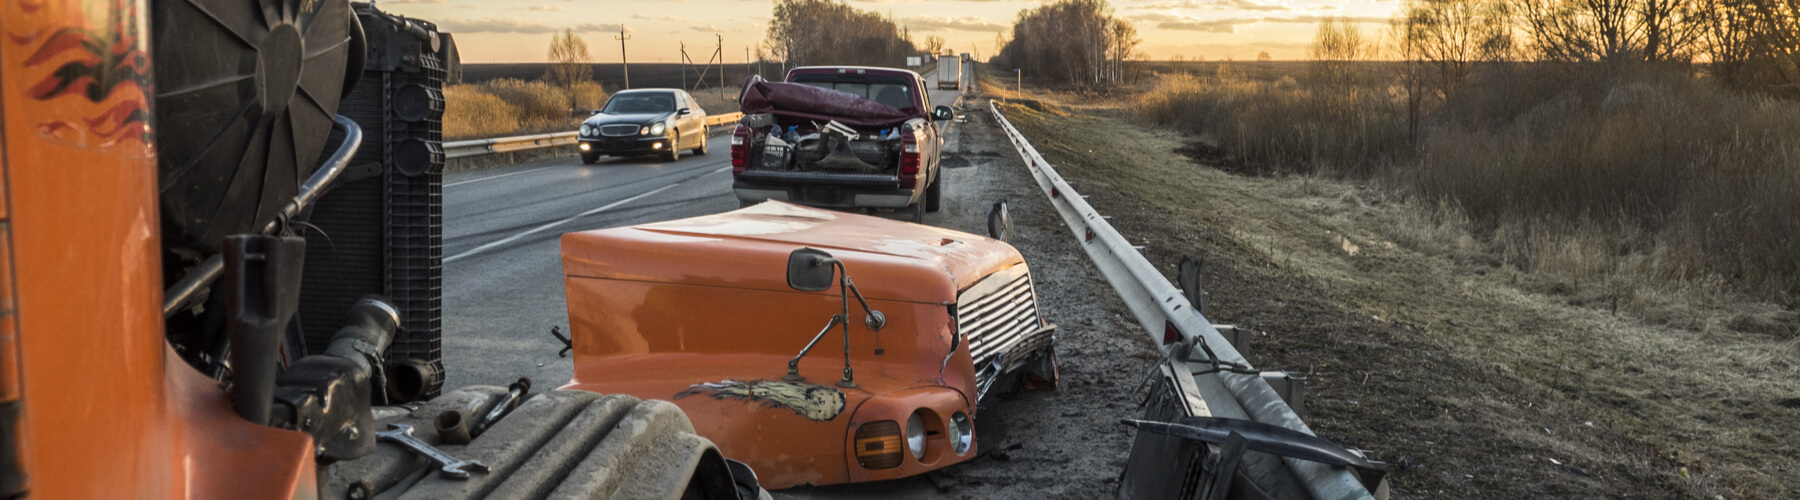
[0,0,317,498]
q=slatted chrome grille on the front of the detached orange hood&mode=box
[956,264,1053,399]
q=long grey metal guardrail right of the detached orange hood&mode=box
[988,101,1373,500]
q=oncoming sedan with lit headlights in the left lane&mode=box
[578,88,706,164]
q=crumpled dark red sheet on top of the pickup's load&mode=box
[738,76,916,126]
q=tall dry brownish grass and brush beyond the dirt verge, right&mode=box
[1129,63,1800,320]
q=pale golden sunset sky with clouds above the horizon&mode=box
[378,0,1399,63]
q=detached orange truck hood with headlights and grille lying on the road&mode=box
[562,201,1057,489]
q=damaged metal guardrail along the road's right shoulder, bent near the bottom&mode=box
[988,101,1373,500]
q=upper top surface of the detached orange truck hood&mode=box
[562,201,1024,304]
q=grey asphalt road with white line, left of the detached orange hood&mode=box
[443,63,976,388]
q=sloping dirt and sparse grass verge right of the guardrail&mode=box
[1000,98,1800,498]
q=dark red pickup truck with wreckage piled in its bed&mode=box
[731,67,954,223]
